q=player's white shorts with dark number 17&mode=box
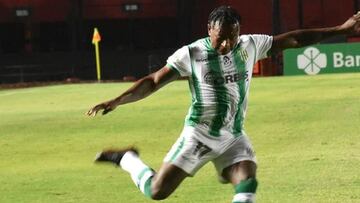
[164,126,256,180]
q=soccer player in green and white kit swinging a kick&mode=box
[87,6,360,203]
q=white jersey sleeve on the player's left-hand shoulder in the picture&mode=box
[166,46,191,76]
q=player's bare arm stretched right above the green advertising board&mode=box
[270,11,360,54]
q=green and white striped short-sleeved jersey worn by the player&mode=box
[167,35,273,137]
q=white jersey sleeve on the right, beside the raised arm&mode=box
[250,35,273,60]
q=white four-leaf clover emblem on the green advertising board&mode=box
[297,47,327,75]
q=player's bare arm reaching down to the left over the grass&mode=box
[86,66,180,116]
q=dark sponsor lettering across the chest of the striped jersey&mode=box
[204,71,249,86]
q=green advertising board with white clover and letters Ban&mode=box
[284,43,360,75]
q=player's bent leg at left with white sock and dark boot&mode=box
[95,147,188,200]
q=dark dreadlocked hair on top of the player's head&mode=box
[208,6,241,25]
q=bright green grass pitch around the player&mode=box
[0,74,360,203]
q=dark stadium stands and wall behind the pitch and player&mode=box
[0,0,360,83]
